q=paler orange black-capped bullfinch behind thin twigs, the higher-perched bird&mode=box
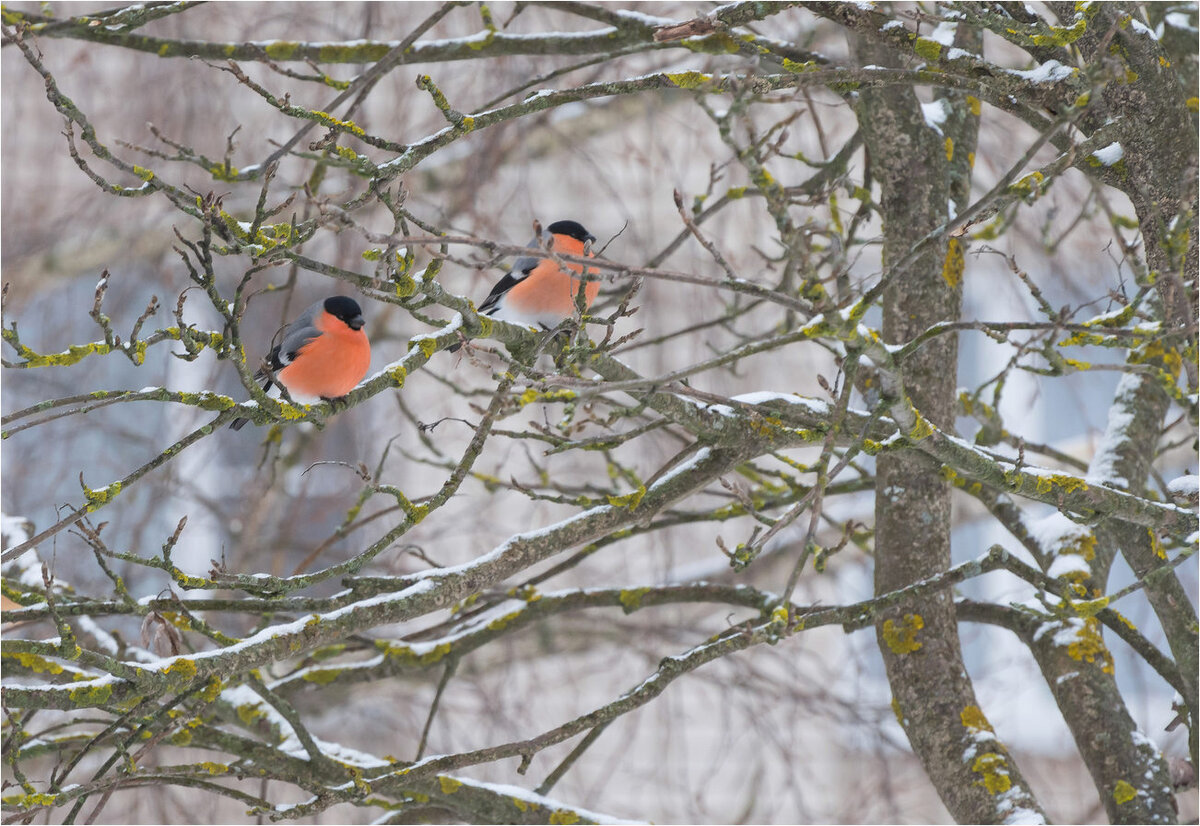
[448,221,600,353]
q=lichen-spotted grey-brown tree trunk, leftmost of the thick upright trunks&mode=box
[854,30,1038,822]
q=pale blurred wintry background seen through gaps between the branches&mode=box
[0,2,1196,822]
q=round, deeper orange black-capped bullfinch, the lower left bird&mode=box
[229,295,371,430]
